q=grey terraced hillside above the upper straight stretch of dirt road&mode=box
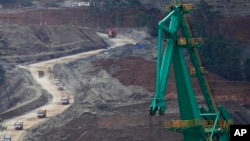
[0,25,106,63]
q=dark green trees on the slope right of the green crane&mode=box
[190,0,247,80]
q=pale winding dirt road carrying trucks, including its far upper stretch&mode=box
[0,33,138,141]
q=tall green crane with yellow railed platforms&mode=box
[150,0,232,141]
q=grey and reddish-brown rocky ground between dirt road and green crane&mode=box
[15,29,249,141]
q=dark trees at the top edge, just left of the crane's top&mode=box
[90,0,161,37]
